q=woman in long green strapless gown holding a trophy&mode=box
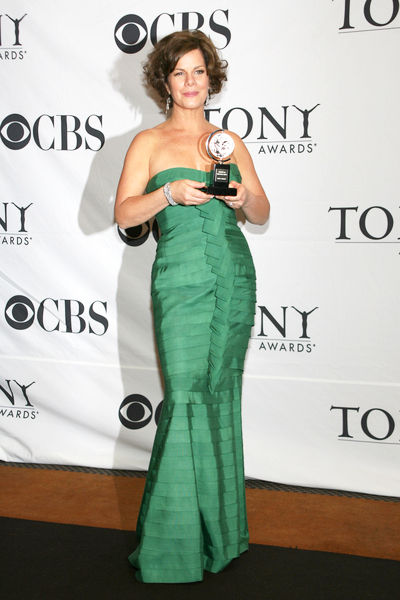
[115,31,269,583]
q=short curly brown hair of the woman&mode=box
[143,30,228,102]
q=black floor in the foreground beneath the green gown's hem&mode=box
[0,517,400,600]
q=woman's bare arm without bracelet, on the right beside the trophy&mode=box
[219,132,270,225]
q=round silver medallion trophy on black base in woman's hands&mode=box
[204,129,237,196]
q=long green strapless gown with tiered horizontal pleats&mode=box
[129,165,255,583]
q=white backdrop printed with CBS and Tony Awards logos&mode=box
[0,0,400,495]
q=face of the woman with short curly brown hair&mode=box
[166,48,209,109]
